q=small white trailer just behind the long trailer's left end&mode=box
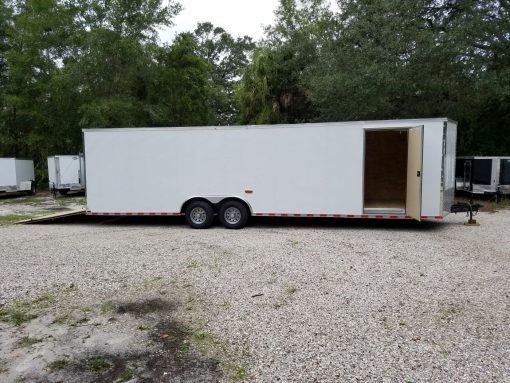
[48,154,85,195]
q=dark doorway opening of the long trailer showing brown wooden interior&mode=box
[364,130,408,209]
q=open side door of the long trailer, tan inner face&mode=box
[406,126,423,221]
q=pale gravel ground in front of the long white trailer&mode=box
[0,210,510,382]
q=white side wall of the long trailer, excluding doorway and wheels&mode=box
[84,119,453,216]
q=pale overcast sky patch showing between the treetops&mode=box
[160,0,279,43]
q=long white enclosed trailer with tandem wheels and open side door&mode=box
[83,118,457,228]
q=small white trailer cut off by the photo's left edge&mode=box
[0,158,35,193]
